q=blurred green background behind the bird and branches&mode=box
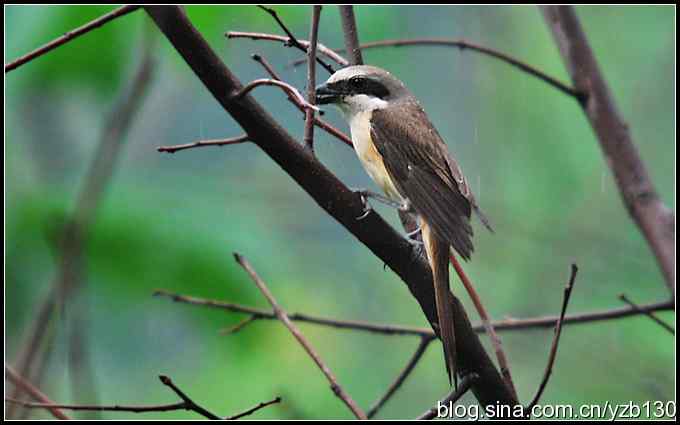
[5,6,675,419]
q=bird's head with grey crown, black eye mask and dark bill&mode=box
[316,65,409,119]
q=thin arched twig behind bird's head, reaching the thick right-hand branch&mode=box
[291,38,583,100]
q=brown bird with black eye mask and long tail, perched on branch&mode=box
[316,65,493,387]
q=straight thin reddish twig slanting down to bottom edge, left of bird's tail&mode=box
[234,253,366,419]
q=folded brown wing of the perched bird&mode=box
[371,101,476,259]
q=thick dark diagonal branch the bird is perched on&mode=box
[146,6,518,405]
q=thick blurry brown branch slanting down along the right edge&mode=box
[542,6,675,294]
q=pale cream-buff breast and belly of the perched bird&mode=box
[349,111,402,202]
